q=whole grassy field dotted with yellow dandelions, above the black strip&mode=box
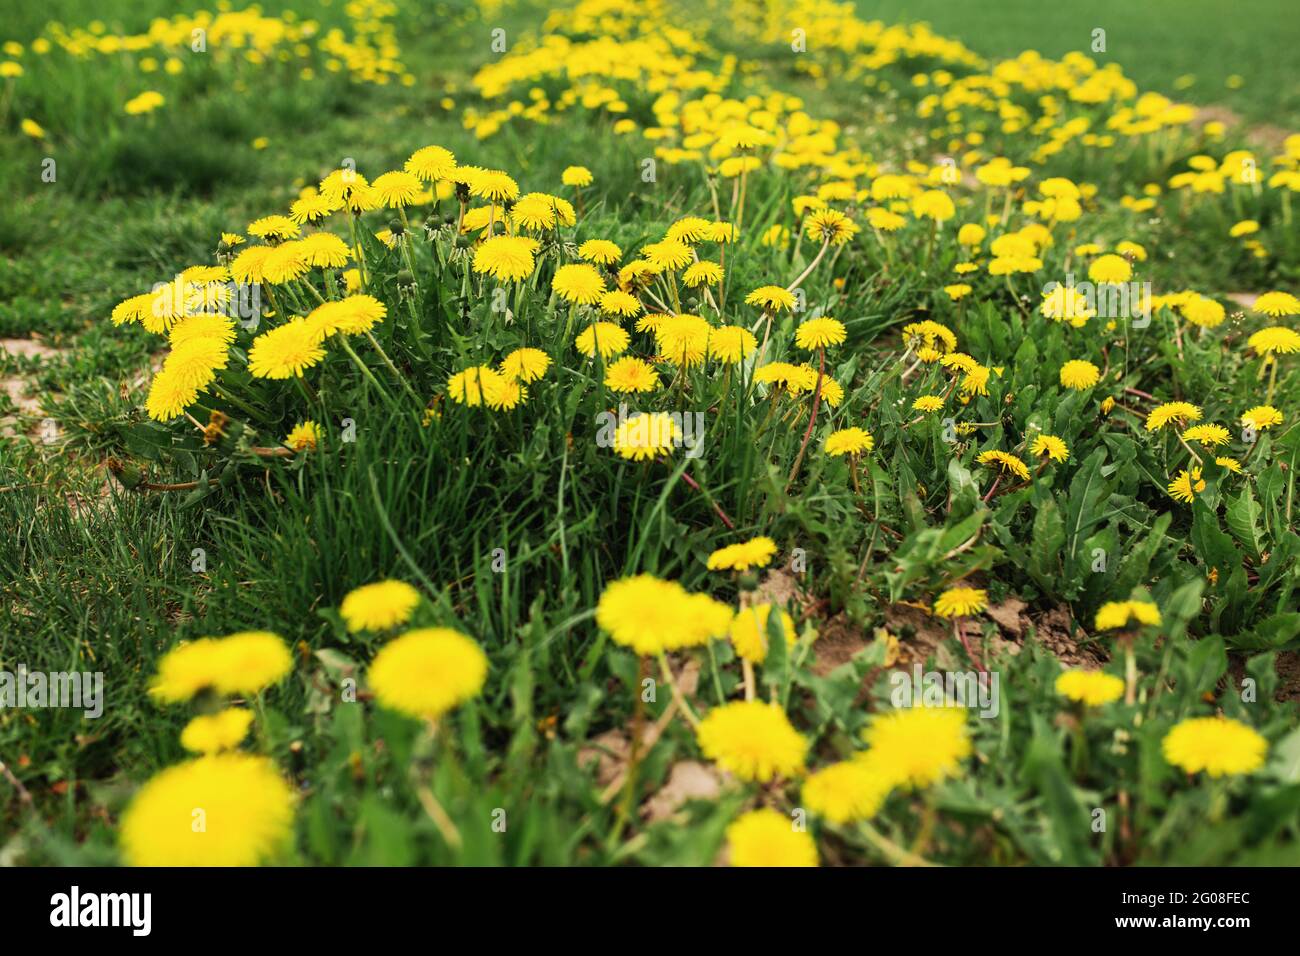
[0,0,1300,866]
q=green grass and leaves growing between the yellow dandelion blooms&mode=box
[0,0,1300,865]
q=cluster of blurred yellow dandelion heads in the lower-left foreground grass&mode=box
[120,580,488,866]
